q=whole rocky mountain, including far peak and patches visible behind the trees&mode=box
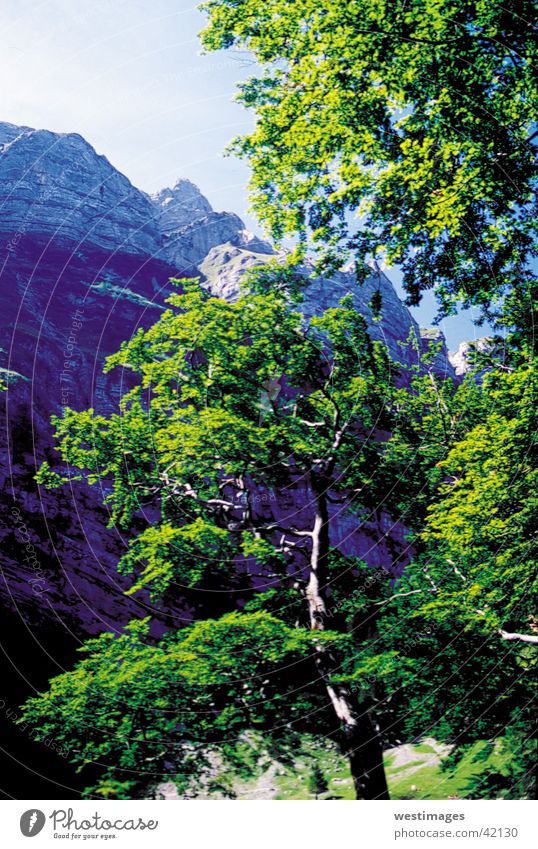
[0,117,451,636]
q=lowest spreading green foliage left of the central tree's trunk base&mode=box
[18,613,324,798]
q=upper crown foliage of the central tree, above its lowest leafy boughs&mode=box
[34,281,393,596]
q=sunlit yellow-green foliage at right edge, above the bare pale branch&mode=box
[423,363,538,630]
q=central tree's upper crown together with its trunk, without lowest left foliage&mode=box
[30,281,402,798]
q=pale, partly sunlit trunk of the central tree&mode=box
[306,475,389,799]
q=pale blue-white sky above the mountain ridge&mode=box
[0,0,484,348]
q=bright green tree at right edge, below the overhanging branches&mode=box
[352,350,538,798]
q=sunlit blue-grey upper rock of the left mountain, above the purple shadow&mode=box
[0,124,160,256]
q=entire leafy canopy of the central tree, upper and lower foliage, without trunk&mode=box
[30,281,406,793]
